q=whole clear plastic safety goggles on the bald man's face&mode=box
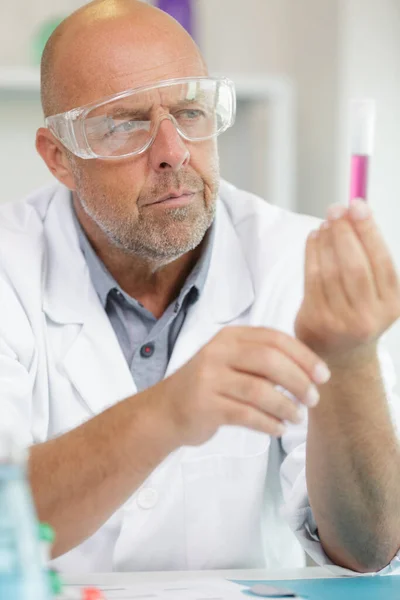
[45,77,236,159]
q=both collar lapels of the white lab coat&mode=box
[43,183,254,414]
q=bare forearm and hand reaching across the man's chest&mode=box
[29,327,329,556]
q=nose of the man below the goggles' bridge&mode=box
[149,117,190,171]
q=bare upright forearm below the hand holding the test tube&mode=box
[307,354,400,571]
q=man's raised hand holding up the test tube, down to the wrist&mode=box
[295,200,400,366]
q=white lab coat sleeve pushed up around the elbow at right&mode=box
[281,340,400,576]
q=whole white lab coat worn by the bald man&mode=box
[0,182,400,572]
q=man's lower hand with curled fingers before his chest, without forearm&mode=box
[153,327,329,446]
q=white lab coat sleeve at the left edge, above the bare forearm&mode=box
[0,274,34,447]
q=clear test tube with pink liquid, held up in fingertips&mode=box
[350,100,375,202]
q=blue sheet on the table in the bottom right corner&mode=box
[236,575,400,600]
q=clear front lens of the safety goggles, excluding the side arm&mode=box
[83,79,233,157]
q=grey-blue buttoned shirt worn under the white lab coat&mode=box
[74,212,215,391]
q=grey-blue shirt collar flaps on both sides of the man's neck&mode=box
[72,205,215,309]
